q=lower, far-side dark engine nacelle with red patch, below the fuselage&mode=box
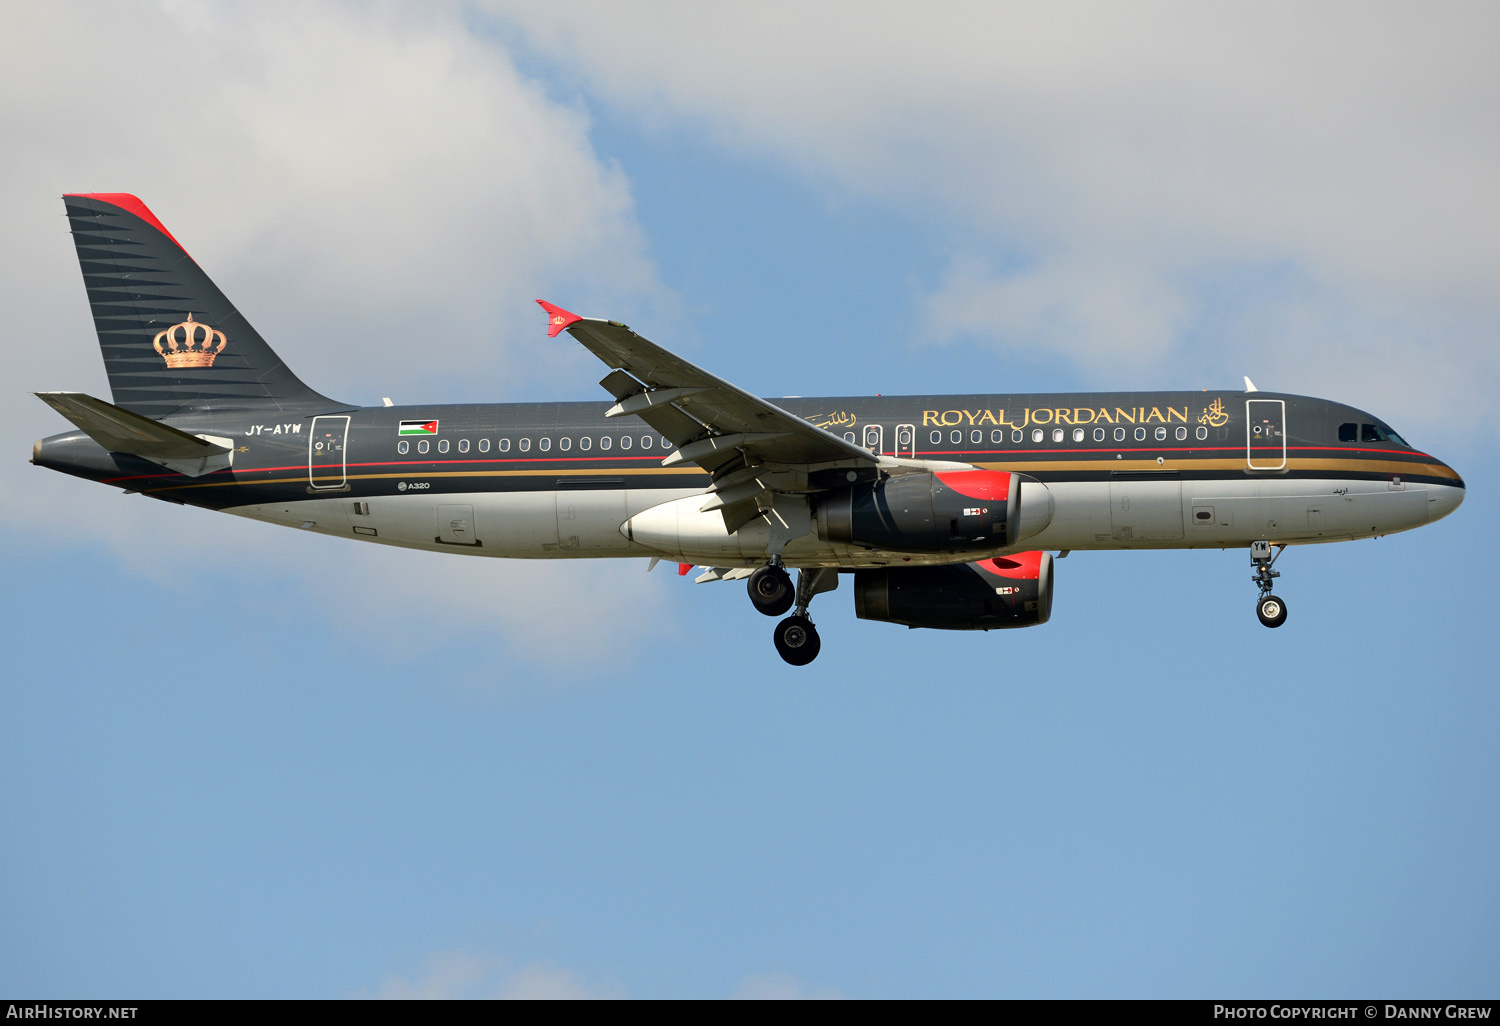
[854,552,1052,630]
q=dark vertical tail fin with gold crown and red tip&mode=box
[63,192,338,419]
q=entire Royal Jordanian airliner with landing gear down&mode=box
[32,194,1464,666]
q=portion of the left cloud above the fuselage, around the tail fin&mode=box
[0,3,672,401]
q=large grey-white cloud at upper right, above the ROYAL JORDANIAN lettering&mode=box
[491,0,1500,438]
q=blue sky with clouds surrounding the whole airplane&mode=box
[0,0,1500,998]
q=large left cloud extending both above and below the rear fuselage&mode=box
[0,0,672,674]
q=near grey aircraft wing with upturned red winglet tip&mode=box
[537,300,881,531]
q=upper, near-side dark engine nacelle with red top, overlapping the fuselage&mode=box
[818,470,1052,552]
